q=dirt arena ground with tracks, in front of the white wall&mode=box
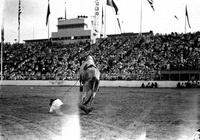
[0,86,200,140]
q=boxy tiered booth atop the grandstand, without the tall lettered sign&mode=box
[51,16,91,43]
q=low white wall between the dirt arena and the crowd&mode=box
[0,80,181,88]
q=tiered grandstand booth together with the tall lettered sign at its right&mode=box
[51,0,102,43]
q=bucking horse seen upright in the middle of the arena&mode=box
[79,55,100,114]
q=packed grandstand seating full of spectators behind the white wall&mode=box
[3,32,200,80]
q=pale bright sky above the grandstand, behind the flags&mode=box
[0,0,200,42]
